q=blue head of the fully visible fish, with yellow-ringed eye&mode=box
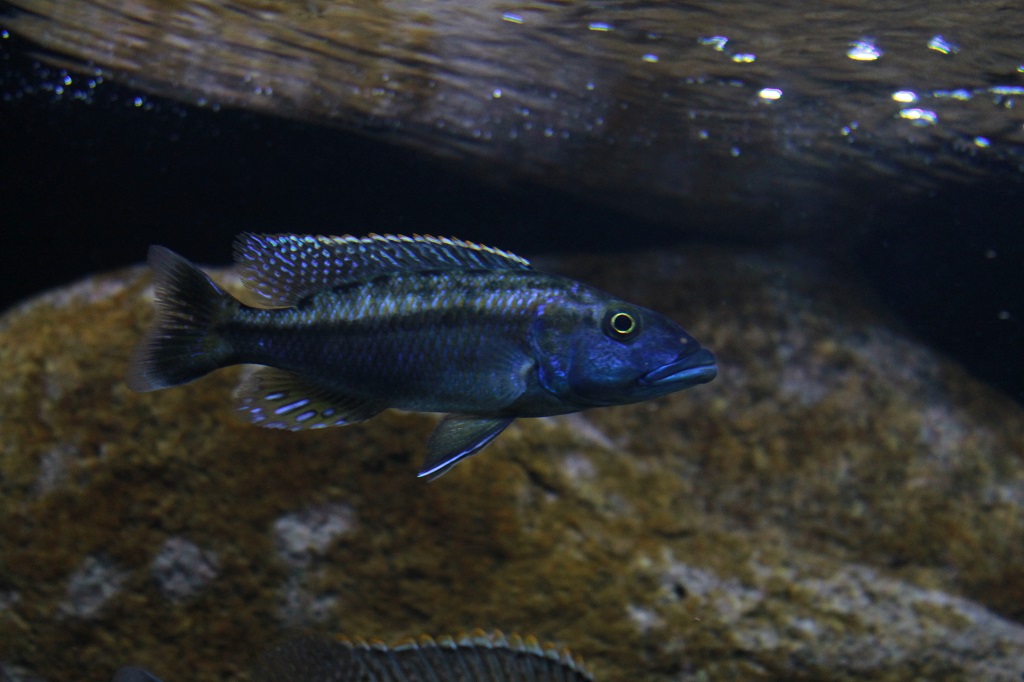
[535,295,718,409]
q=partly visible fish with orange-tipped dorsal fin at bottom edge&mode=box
[114,630,594,682]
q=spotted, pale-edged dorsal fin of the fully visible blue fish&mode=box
[234,233,530,306]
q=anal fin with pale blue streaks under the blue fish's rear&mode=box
[234,367,387,431]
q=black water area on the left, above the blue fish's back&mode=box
[0,76,676,307]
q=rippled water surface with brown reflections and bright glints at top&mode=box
[4,0,1024,236]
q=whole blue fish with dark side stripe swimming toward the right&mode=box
[126,233,718,479]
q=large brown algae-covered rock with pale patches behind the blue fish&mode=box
[0,247,1024,682]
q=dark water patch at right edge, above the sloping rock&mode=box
[856,185,1024,402]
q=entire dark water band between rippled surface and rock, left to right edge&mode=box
[0,30,1024,401]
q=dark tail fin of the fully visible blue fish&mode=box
[125,246,238,391]
